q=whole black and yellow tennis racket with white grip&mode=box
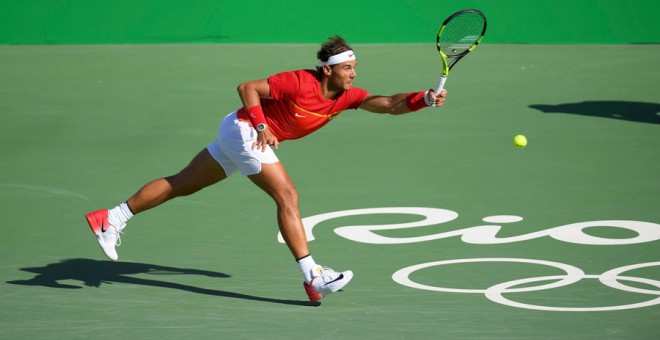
[434,9,486,102]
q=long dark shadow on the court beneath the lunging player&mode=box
[7,259,320,306]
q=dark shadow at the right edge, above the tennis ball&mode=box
[529,100,660,124]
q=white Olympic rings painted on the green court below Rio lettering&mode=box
[392,258,660,312]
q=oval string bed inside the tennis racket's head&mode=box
[438,13,485,57]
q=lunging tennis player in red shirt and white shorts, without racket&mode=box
[86,36,446,301]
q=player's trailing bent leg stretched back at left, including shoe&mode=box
[85,149,227,261]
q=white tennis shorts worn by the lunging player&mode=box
[206,112,279,176]
